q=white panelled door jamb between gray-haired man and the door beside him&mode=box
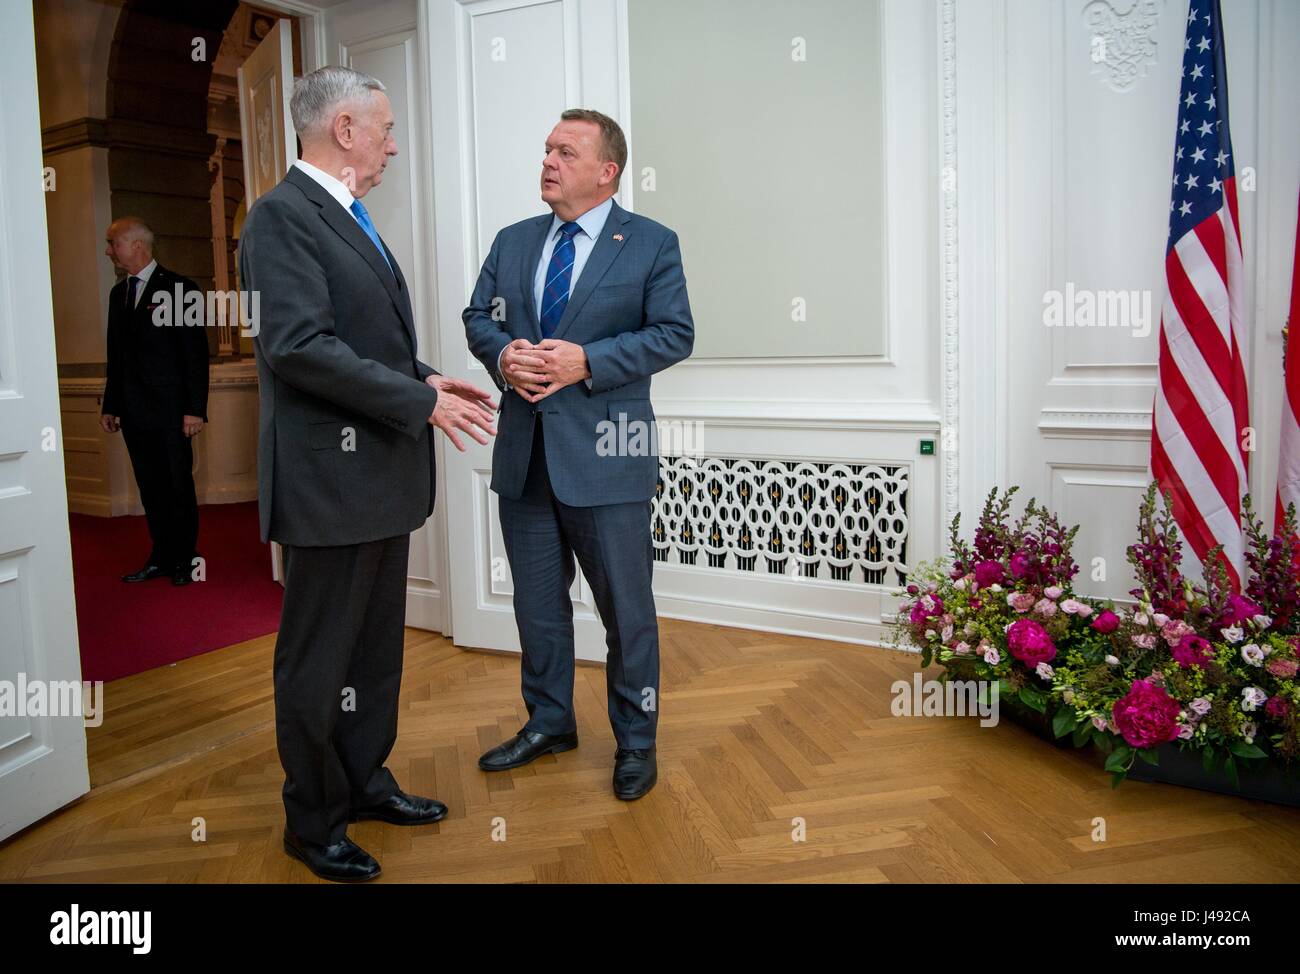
[320,0,449,632]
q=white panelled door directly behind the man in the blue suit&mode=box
[428,0,618,661]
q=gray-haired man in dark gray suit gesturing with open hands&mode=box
[239,68,497,880]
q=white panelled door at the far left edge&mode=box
[0,4,90,839]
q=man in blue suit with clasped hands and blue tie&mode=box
[463,109,694,800]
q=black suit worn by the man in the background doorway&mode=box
[103,264,208,581]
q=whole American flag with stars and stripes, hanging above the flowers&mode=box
[1151,0,1251,588]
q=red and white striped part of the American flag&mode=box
[1151,178,1249,588]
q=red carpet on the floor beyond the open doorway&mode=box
[69,502,283,680]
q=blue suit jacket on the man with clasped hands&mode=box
[463,195,696,507]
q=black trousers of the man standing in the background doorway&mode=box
[122,417,199,571]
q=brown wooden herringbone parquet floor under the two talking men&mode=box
[0,619,1300,883]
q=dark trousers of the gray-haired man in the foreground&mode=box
[276,534,411,845]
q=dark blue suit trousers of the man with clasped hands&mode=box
[498,416,659,748]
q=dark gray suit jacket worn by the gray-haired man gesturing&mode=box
[239,166,438,546]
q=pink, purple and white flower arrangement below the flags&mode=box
[896,484,1300,787]
